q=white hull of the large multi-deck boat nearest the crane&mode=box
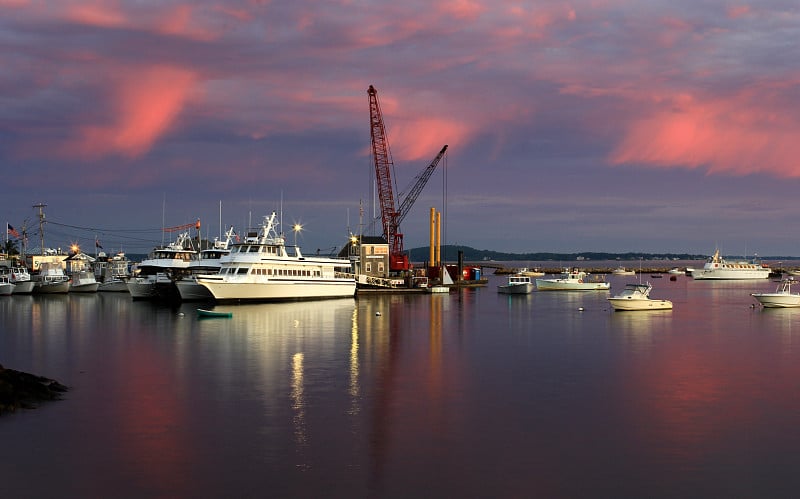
[199,278,356,302]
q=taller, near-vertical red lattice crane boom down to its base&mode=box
[367,85,408,271]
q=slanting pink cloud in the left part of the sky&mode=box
[65,66,197,158]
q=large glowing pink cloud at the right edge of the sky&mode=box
[610,85,800,177]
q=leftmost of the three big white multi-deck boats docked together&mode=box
[126,232,197,300]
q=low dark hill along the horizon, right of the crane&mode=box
[409,245,797,262]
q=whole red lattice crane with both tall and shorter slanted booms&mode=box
[367,85,447,272]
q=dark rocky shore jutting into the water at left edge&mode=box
[0,365,67,416]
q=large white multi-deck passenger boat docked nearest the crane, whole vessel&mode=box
[197,212,356,302]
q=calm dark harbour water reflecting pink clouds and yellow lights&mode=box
[0,276,800,498]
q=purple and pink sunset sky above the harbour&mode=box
[0,0,800,256]
